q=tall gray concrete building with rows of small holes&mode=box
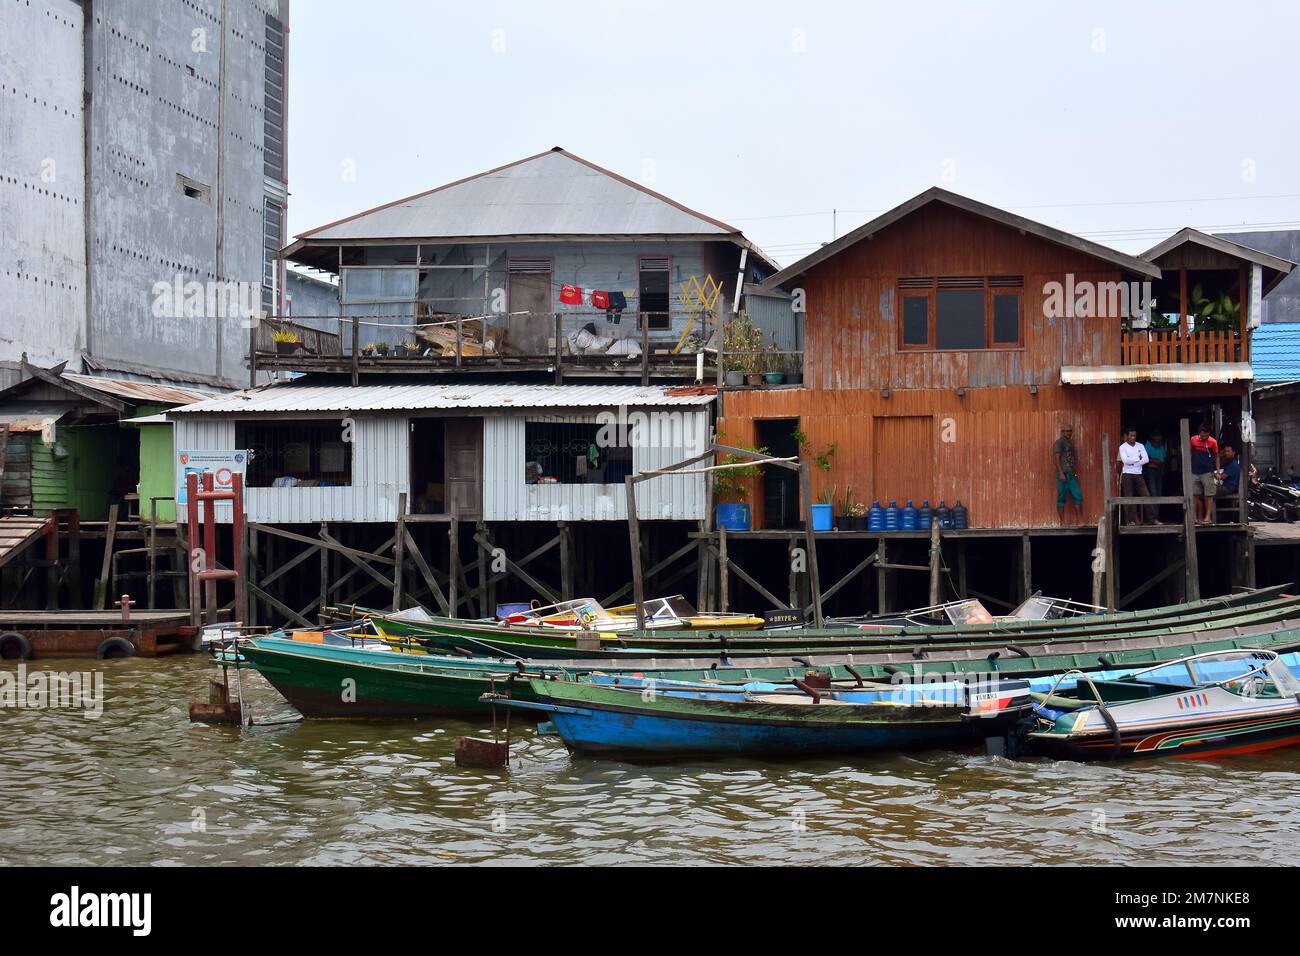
[0,0,289,386]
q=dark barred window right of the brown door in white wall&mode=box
[524,421,632,485]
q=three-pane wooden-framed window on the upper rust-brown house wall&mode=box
[898,276,1024,351]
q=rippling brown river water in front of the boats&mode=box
[0,656,1300,866]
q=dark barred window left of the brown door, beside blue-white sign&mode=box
[235,421,352,488]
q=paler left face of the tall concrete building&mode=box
[0,0,86,388]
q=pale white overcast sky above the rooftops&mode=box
[289,0,1300,264]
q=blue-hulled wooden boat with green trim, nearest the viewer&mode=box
[485,678,1030,757]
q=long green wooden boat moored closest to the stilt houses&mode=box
[395,597,1300,659]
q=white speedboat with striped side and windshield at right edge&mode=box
[1027,650,1300,760]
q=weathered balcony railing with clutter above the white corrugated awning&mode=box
[250,310,718,382]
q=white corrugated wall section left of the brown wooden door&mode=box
[176,415,410,524]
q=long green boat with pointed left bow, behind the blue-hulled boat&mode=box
[231,620,1300,717]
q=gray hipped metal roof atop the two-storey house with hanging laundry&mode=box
[298,148,740,241]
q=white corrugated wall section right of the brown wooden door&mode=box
[484,408,709,522]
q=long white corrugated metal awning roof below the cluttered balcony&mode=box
[169,384,716,415]
